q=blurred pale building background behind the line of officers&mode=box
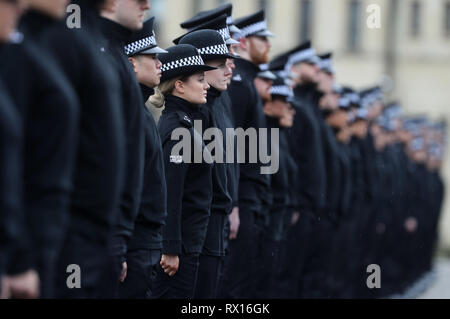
[150,0,450,256]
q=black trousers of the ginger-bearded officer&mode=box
[220,207,262,299]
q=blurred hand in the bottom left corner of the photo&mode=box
[6,270,39,299]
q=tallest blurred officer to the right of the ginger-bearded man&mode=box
[268,41,326,297]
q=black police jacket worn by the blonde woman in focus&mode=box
[158,95,213,255]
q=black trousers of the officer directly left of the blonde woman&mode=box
[119,249,161,299]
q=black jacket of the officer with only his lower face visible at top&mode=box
[99,17,144,256]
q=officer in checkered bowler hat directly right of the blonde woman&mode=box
[180,30,234,299]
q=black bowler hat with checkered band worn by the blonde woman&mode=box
[158,44,217,82]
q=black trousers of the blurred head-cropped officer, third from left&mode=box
[56,235,111,299]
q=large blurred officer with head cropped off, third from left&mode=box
[33,0,124,298]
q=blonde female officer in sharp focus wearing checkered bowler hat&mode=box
[151,44,216,299]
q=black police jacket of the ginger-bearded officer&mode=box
[228,59,270,214]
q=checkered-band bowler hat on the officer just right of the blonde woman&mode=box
[179,30,235,61]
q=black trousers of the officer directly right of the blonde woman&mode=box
[195,255,223,299]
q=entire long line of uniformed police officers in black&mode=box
[0,0,445,298]
